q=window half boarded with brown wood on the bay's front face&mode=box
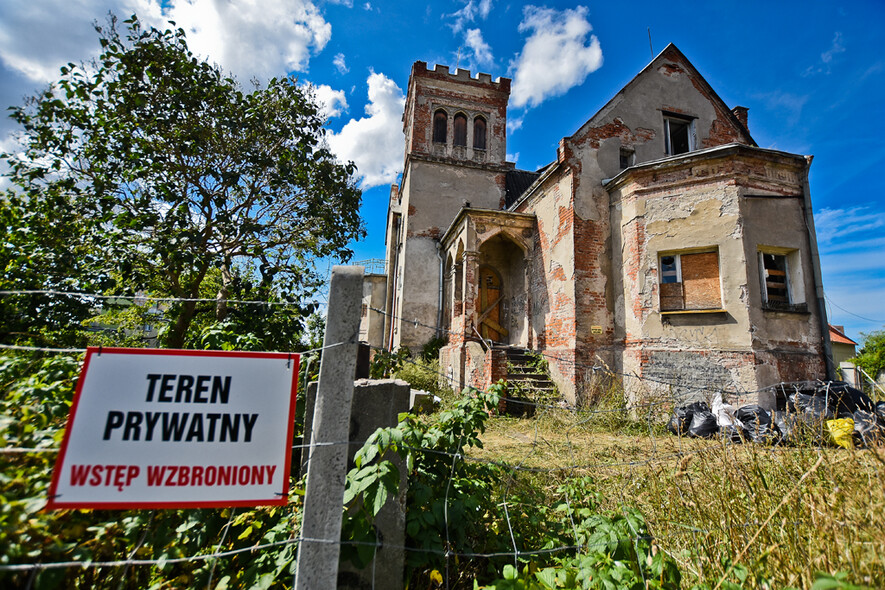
[659,252,722,311]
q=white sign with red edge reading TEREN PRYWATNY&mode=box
[48,348,299,509]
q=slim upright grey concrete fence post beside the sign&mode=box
[295,266,363,590]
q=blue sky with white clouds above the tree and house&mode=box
[0,0,885,339]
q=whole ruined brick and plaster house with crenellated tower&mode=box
[365,45,832,410]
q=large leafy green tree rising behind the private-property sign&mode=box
[2,16,364,347]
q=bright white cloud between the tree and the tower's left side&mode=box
[328,72,406,189]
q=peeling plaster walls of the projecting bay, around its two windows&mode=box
[611,148,824,405]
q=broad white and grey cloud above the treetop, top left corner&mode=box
[0,0,332,83]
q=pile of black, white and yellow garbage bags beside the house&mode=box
[668,381,885,448]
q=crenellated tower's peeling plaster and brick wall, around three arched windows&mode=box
[391,62,510,348]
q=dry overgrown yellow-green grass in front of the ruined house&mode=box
[471,400,885,588]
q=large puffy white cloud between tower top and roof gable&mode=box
[510,6,602,108]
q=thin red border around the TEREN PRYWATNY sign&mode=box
[44,346,301,510]
